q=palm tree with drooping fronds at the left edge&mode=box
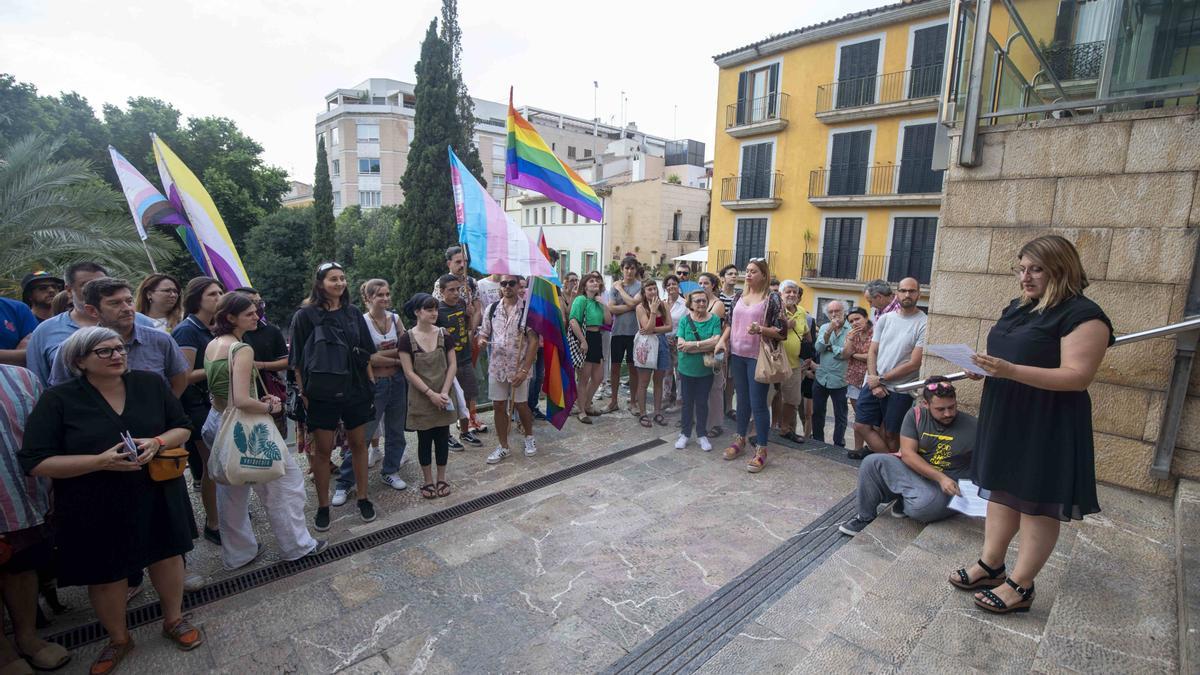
[0,133,172,295]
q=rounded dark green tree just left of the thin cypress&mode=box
[242,207,313,325]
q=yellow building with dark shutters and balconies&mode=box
[708,0,949,316]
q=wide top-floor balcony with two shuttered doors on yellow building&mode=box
[816,64,944,124]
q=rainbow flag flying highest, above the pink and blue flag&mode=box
[505,98,604,221]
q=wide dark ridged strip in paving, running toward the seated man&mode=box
[606,492,857,674]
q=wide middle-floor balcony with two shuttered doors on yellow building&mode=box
[809,162,944,207]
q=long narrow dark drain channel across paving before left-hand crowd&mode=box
[44,438,665,650]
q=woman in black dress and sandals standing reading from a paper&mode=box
[949,235,1112,614]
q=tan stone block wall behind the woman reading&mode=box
[922,107,1200,494]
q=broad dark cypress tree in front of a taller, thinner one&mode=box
[392,19,463,301]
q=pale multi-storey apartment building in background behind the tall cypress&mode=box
[316,78,666,213]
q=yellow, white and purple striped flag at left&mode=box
[150,133,251,291]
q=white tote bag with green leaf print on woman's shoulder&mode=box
[208,350,287,485]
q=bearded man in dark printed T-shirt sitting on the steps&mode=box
[838,376,976,537]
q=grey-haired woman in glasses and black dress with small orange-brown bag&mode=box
[19,327,204,673]
